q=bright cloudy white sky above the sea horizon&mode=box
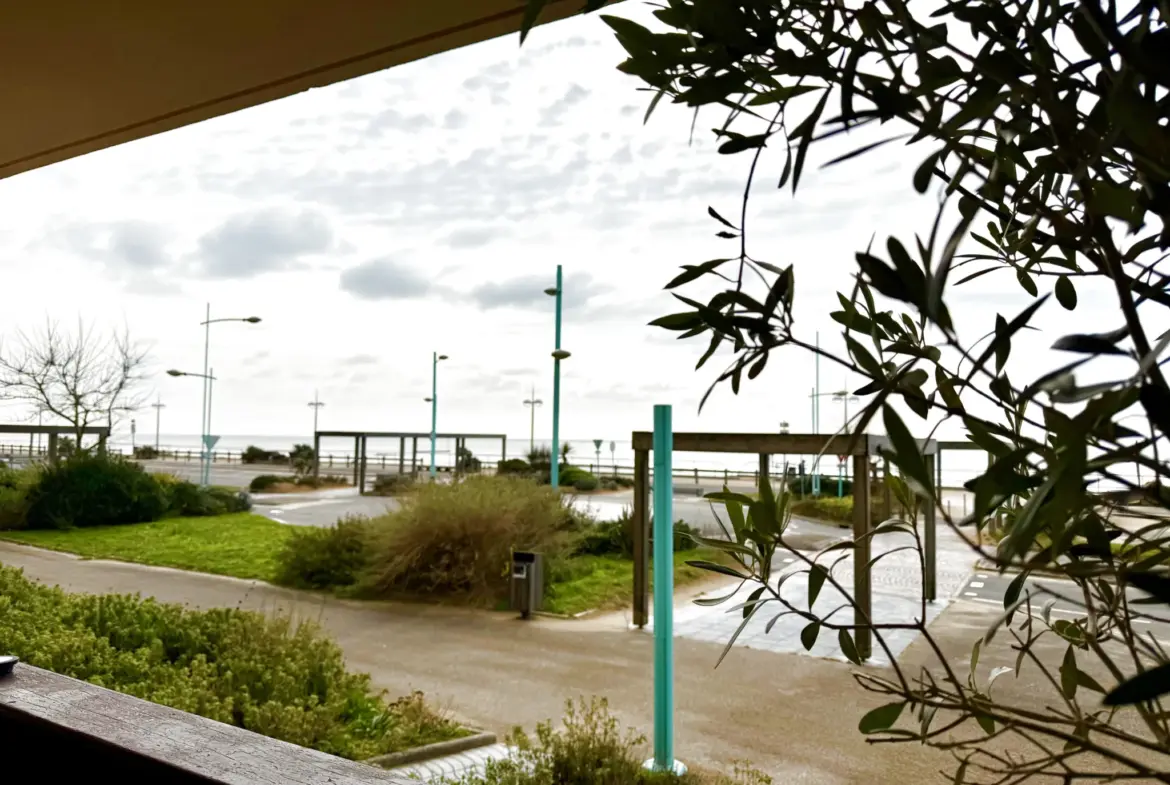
[0,7,1141,451]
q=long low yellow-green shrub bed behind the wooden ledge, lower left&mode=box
[0,566,461,759]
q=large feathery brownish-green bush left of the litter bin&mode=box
[363,475,571,600]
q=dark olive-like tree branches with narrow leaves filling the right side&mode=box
[532,0,1170,783]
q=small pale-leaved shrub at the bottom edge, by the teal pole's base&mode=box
[460,697,772,785]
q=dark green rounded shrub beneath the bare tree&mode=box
[25,453,170,529]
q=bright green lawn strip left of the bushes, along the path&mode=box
[0,512,293,580]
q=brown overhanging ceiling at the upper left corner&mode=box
[0,0,581,178]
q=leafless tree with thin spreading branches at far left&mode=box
[0,319,147,448]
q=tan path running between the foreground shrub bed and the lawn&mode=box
[0,543,996,785]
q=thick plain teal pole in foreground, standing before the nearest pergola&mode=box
[646,405,687,774]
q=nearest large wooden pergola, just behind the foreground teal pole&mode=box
[632,431,938,659]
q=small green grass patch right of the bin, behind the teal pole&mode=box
[544,549,720,615]
